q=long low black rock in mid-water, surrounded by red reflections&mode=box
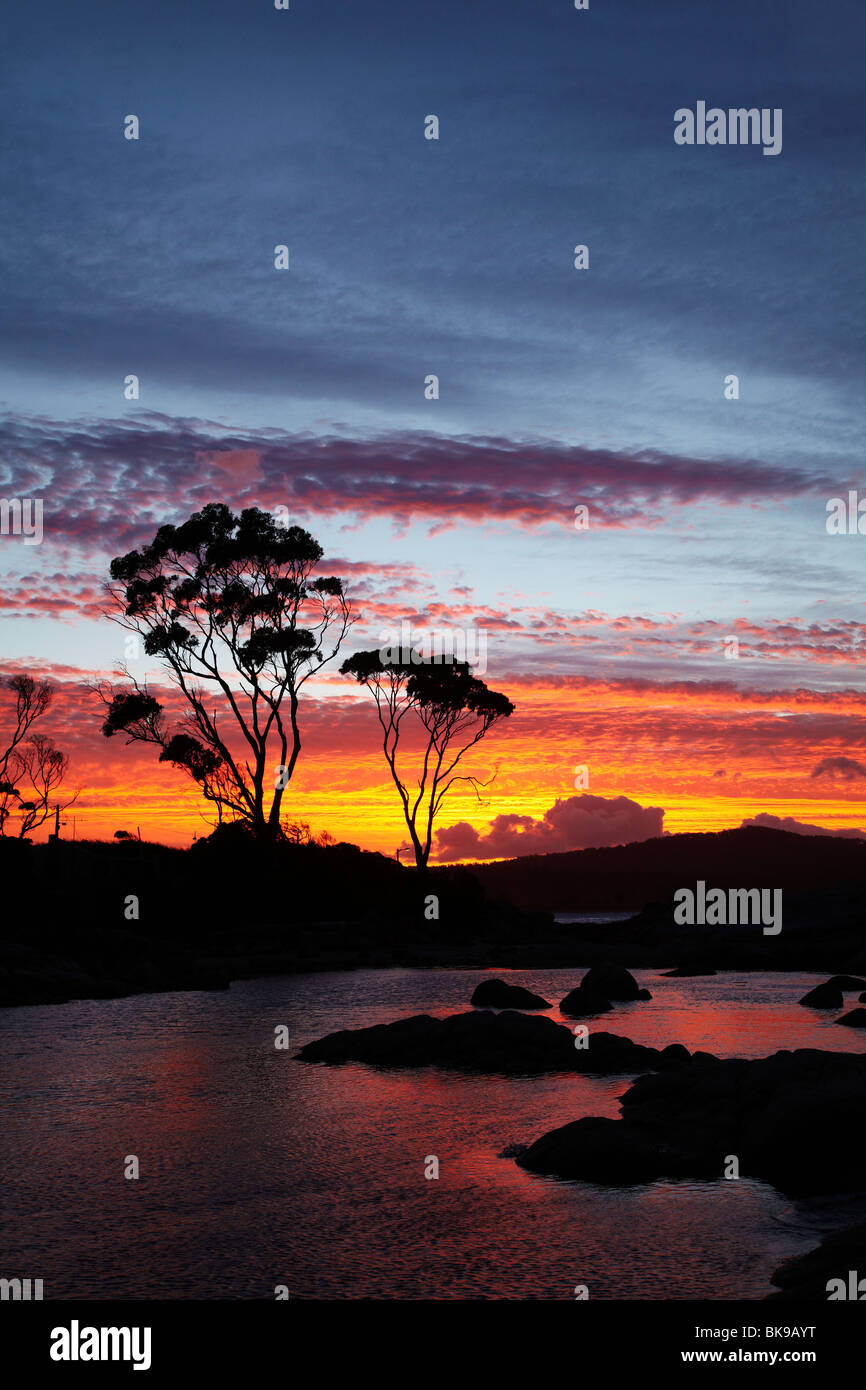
[297,1009,688,1076]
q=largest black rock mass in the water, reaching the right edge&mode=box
[518,1050,866,1197]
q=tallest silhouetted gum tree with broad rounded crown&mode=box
[99,502,352,837]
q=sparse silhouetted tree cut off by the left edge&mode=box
[0,676,78,840]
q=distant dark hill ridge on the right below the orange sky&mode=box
[466,826,866,912]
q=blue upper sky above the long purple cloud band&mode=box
[4,0,866,463]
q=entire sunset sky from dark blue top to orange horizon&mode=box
[0,0,866,862]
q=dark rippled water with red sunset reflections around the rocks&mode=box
[0,970,866,1300]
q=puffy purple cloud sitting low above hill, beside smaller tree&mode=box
[435,794,664,863]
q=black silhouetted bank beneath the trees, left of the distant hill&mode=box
[0,826,553,1008]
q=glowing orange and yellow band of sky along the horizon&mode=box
[3,658,866,858]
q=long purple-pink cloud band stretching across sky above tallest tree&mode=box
[0,411,838,549]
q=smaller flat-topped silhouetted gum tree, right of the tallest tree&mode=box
[341,652,514,869]
